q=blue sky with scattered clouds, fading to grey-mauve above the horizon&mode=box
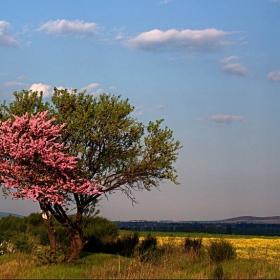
[0,0,280,221]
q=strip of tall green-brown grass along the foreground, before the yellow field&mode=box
[0,233,280,279]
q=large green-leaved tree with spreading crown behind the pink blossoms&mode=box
[0,89,181,258]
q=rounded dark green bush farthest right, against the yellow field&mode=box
[208,239,236,263]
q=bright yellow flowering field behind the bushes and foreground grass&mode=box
[141,236,280,263]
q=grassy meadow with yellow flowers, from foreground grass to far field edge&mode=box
[0,233,280,279]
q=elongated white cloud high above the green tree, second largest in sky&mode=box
[37,19,97,35]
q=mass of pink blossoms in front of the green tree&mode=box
[0,111,104,204]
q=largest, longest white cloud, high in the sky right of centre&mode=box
[127,29,230,52]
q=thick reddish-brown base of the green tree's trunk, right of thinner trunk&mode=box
[66,228,85,262]
